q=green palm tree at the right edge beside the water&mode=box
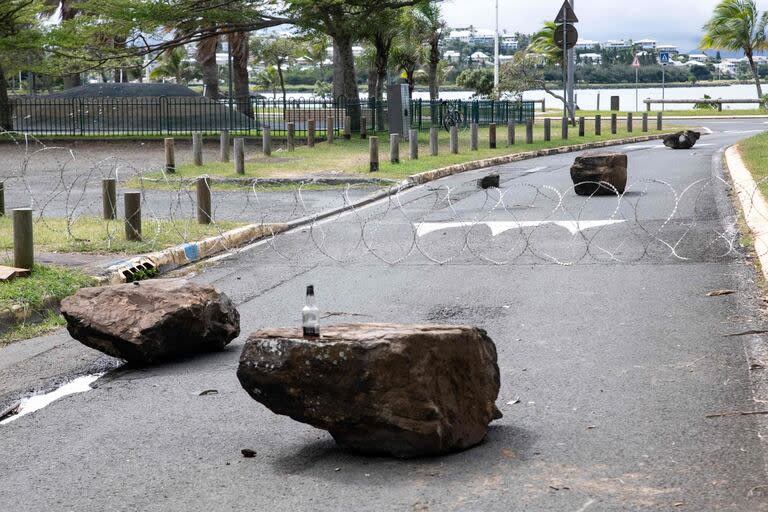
[701,0,768,98]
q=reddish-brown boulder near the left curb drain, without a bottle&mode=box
[61,279,240,364]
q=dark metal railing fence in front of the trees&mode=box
[11,97,534,137]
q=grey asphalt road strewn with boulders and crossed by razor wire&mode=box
[0,120,768,512]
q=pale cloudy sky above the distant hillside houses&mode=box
[443,0,768,51]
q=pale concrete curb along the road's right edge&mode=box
[725,146,768,279]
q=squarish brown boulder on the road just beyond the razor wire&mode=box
[571,153,627,196]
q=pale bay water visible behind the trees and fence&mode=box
[282,84,757,111]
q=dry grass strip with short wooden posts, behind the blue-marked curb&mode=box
[0,217,242,254]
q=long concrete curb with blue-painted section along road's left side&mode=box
[99,132,672,283]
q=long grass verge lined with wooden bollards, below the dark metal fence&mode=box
[133,120,668,187]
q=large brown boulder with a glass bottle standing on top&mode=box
[237,324,501,457]
